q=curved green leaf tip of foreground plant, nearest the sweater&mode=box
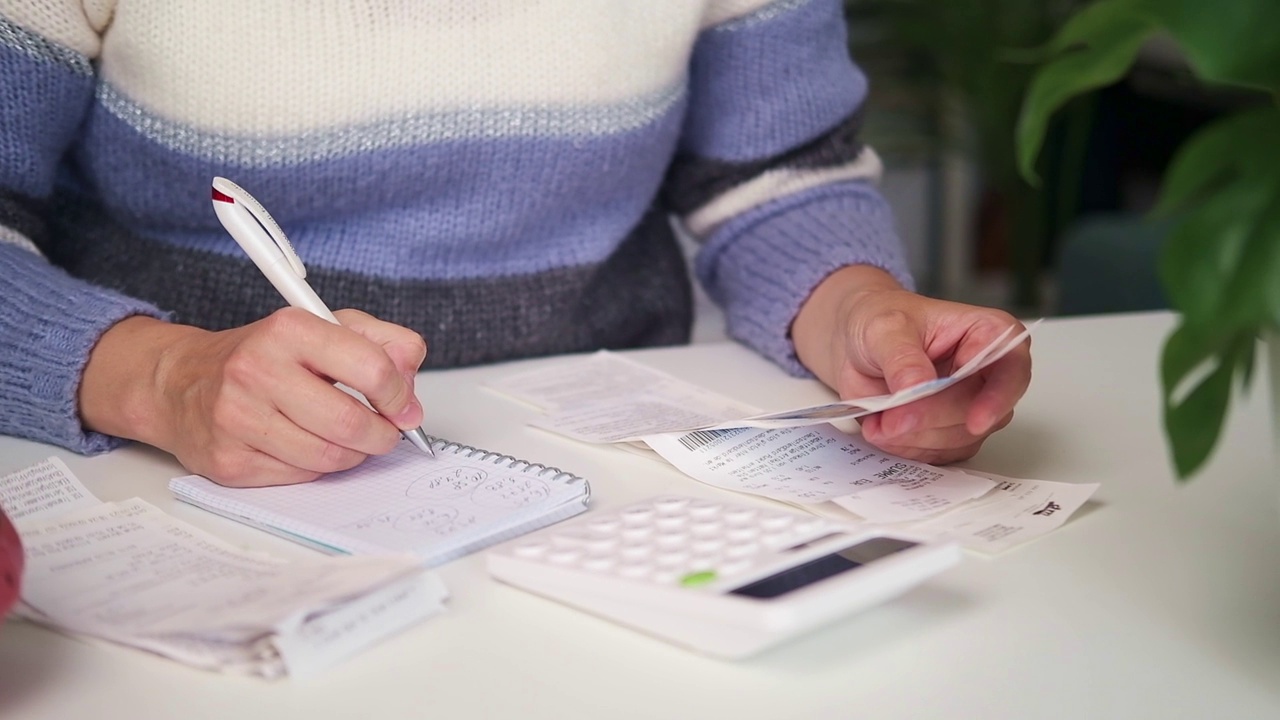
[1016,0,1156,183]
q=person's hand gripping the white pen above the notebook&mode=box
[79,307,426,487]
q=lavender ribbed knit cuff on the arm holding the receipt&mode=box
[696,182,914,377]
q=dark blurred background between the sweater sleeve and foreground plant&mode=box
[845,0,1257,316]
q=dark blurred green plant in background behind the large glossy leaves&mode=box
[845,0,1091,307]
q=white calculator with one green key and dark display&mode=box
[486,496,960,659]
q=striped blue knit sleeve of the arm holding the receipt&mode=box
[663,0,913,374]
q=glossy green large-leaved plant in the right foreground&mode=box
[1016,0,1280,479]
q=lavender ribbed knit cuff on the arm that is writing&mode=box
[0,243,164,455]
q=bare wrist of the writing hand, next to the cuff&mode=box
[77,315,205,447]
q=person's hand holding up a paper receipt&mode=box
[791,265,1032,464]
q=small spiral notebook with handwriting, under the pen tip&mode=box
[169,439,591,566]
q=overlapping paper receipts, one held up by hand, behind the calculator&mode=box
[490,322,1098,553]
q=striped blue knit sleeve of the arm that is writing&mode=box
[0,18,161,454]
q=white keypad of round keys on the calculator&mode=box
[511,497,832,587]
